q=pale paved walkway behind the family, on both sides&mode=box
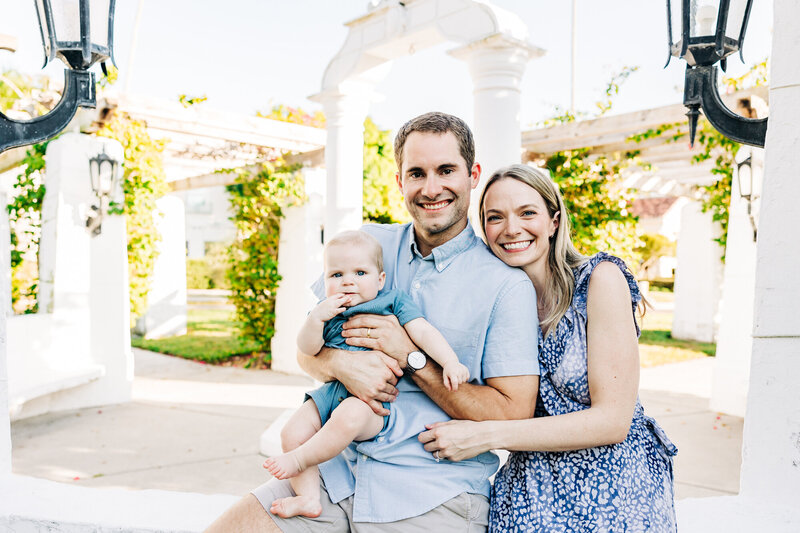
[11,350,742,499]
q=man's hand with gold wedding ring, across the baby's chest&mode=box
[340,315,419,364]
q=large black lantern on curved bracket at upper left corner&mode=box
[0,0,116,152]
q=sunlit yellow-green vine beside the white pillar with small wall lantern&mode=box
[97,112,168,327]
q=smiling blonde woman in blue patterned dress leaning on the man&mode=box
[420,165,677,532]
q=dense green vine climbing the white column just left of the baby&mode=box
[227,160,305,362]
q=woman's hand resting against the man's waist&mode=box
[418,420,492,461]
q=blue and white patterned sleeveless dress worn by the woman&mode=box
[489,253,678,533]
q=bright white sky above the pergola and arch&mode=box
[0,0,772,130]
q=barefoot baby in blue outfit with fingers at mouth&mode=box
[264,231,469,518]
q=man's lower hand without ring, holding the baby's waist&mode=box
[336,351,403,416]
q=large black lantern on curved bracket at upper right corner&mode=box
[667,0,767,147]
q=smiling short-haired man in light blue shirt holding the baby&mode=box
[209,113,539,532]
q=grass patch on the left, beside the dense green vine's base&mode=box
[131,307,264,364]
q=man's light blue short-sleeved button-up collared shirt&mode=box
[313,223,539,522]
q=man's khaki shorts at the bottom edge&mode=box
[253,479,489,533]
